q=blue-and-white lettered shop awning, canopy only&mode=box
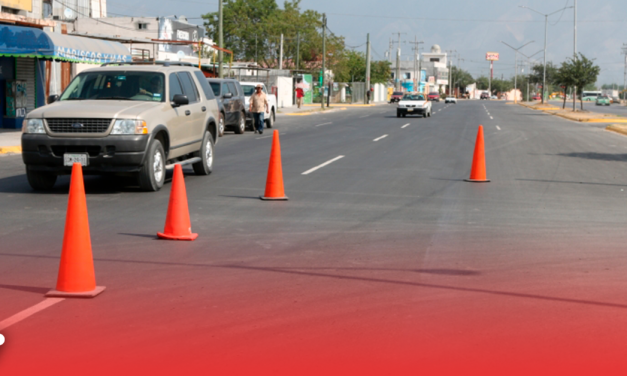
[0,25,132,64]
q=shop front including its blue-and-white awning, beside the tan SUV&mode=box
[0,25,132,128]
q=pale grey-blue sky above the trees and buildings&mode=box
[107,0,627,85]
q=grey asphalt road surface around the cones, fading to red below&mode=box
[0,101,627,375]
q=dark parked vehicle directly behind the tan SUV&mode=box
[207,78,246,136]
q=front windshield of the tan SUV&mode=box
[60,71,165,102]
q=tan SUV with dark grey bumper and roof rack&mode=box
[22,62,220,191]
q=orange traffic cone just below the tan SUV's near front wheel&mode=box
[157,165,198,240]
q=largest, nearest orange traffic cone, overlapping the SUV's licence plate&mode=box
[46,163,105,298]
